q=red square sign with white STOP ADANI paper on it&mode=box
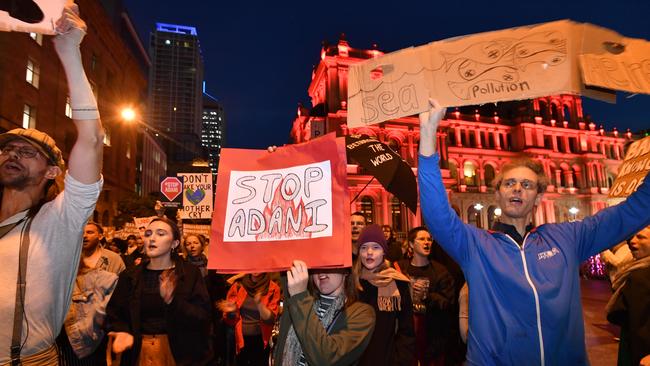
[208,134,352,273]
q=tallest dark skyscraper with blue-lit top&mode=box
[149,23,205,174]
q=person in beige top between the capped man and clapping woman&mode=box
[56,222,126,366]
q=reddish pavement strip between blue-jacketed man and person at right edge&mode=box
[581,279,618,366]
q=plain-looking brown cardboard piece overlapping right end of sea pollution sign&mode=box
[580,37,650,94]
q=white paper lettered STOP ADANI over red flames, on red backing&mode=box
[223,161,332,242]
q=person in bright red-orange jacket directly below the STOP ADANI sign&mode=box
[221,273,281,365]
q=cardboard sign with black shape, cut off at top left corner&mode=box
[0,0,68,34]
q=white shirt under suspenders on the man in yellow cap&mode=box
[0,174,104,364]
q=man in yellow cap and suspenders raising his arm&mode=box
[0,2,104,365]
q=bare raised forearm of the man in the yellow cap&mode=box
[54,2,104,184]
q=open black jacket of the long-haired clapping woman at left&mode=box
[106,260,212,365]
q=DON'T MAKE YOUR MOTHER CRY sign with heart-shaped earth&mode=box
[178,173,212,219]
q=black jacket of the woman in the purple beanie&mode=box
[359,280,415,366]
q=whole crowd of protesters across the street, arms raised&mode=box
[0,4,650,366]
